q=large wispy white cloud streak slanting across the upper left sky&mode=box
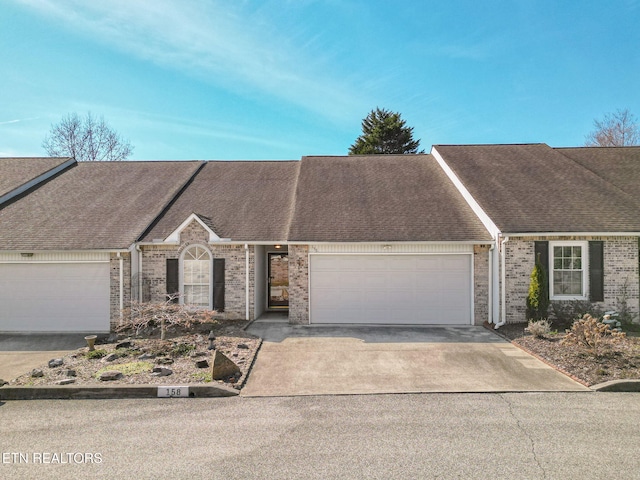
[13,0,363,124]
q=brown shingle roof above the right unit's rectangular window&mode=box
[434,144,640,233]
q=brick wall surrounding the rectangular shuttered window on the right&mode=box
[506,237,640,323]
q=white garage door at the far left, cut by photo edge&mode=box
[0,263,110,333]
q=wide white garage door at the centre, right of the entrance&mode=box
[309,254,472,325]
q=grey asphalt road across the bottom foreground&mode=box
[0,393,640,480]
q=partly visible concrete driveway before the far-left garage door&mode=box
[0,333,87,381]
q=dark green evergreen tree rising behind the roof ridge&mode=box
[349,107,424,155]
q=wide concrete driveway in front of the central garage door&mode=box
[241,321,589,396]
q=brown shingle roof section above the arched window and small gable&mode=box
[142,161,300,242]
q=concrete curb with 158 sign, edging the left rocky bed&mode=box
[0,382,240,400]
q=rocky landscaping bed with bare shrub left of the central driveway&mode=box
[9,321,261,390]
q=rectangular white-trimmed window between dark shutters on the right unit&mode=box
[549,242,589,300]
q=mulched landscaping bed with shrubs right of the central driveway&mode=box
[497,323,640,386]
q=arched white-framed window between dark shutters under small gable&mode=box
[181,245,212,308]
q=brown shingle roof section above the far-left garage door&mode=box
[0,162,202,250]
